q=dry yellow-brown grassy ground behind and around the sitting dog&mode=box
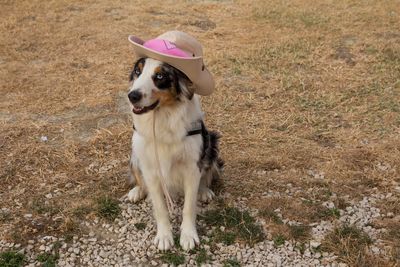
[0,0,400,266]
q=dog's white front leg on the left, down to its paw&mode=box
[147,176,174,250]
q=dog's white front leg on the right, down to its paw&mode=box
[180,164,201,250]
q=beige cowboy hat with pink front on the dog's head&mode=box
[128,31,215,96]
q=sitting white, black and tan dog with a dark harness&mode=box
[128,32,223,250]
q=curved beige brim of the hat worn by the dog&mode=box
[128,35,215,96]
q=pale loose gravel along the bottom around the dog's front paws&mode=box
[0,187,392,267]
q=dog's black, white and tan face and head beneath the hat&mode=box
[128,58,193,114]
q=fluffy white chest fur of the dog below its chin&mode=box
[132,96,202,193]
